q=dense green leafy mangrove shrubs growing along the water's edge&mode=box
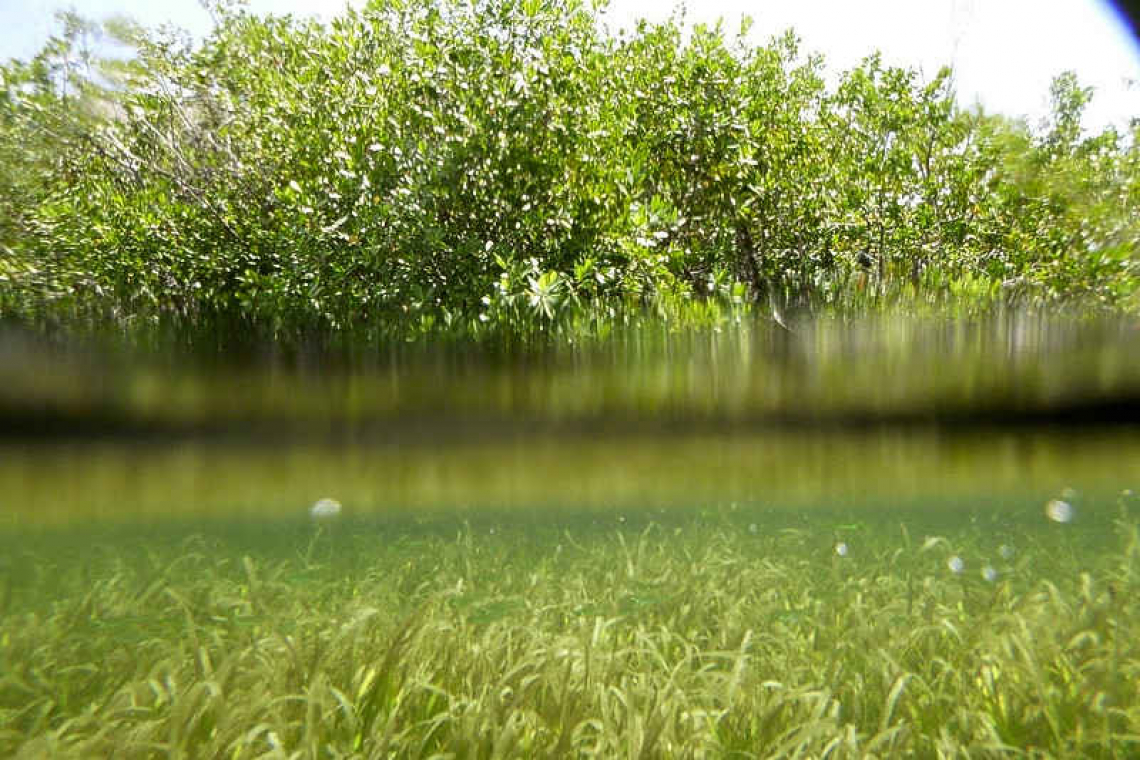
[0,0,1140,337]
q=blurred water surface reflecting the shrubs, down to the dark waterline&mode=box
[0,310,1140,439]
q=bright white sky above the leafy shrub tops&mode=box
[0,0,1140,129]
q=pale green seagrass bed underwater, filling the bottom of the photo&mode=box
[0,495,1140,759]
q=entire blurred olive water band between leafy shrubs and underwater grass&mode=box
[0,314,1140,528]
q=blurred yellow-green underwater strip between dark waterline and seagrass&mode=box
[0,427,1140,526]
